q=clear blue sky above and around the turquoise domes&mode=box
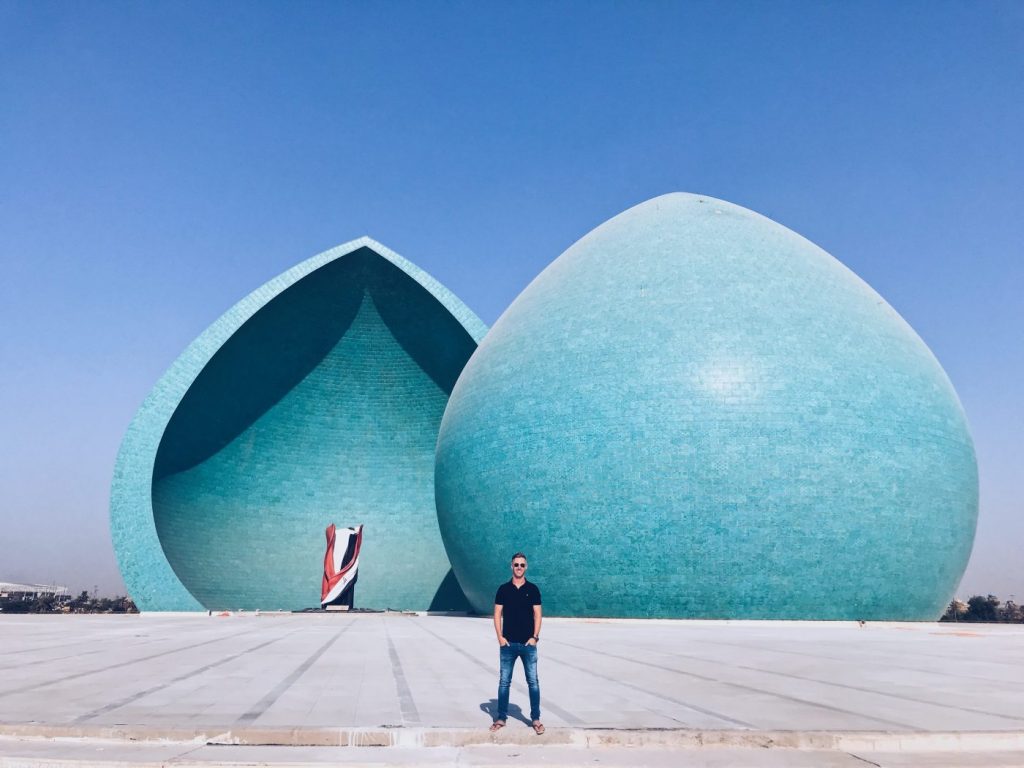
[0,0,1024,600]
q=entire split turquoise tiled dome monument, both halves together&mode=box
[111,195,978,620]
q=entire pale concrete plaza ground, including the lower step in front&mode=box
[0,613,1024,766]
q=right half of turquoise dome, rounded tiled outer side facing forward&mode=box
[435,194,978,620]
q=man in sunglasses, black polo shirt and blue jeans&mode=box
[490,552,544,735]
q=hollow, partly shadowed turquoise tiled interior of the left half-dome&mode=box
[152,247,476,609]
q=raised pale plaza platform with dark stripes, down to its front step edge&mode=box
[0,613,1024,732]
